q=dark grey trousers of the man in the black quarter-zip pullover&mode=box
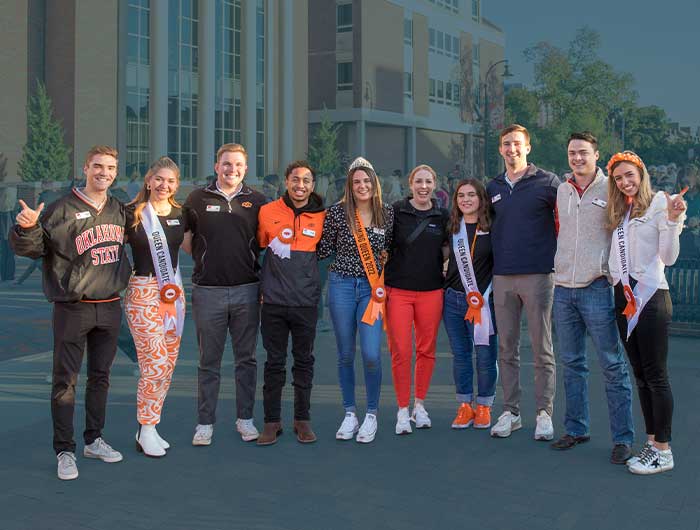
[192,283,260,425]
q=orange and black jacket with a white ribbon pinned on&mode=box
[258,193,326,307]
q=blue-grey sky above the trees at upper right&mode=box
[481,0,700,131]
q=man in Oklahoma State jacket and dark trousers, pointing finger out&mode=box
[10,145,131,480]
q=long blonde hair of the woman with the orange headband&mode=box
[606,151,654,230]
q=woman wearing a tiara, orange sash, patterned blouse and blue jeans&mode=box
[317,157,394,443]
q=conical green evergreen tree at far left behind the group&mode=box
[18,82,71,182]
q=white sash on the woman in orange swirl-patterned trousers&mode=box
[141,202,185,337]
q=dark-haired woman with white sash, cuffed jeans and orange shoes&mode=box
[443,179,498,429]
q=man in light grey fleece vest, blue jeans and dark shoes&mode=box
[552,132,634,464]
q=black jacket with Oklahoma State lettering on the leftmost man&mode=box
[10,191,131,302]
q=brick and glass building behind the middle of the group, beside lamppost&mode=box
[309,0,505,176]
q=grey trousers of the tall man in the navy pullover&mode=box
[493,274,556,416]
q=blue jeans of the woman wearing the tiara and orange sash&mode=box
[328,272,383,414]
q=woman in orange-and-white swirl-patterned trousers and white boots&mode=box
[125,157,187,457]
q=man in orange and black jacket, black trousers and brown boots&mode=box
[258,160,325,445]
